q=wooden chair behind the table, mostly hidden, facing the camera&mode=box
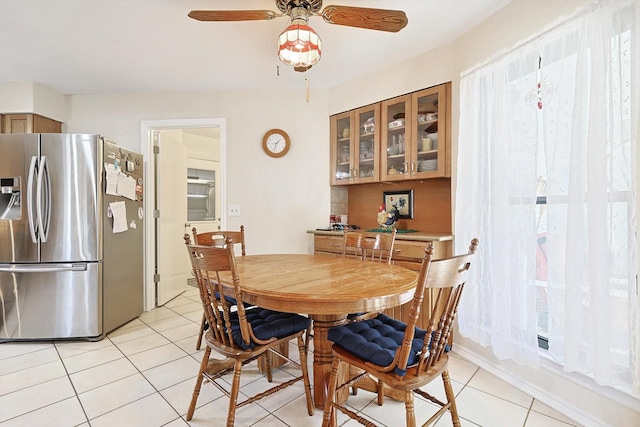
[342,228,396,322]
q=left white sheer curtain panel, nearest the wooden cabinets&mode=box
[455,41,538,365]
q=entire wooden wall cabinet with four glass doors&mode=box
[330,82,451,185]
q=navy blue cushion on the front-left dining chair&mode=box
[230,307,309,350]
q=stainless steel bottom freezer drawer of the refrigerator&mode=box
[0,263,102,341]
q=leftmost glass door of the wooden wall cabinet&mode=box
[330,111,354,185]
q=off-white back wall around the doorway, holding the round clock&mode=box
[67,87,330,254]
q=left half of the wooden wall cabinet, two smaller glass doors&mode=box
[330,104,380,185]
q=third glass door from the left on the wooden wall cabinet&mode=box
[380,95,411,181]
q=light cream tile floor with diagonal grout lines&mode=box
[0,289,578,427]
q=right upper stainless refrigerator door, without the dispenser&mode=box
[37,133,102,262]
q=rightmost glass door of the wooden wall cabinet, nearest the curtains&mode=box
[411,85,447,179]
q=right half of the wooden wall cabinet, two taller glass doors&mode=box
[380,83,451,181]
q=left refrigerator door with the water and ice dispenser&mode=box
[0,134,39,263]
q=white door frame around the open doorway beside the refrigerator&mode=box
[140,118,227,311]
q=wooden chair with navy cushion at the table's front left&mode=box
[185,235,314,427]
